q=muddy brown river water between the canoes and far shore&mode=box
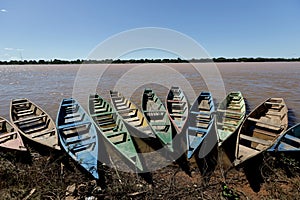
[0,62,300,170]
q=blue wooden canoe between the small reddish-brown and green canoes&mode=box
[187,92,215,159]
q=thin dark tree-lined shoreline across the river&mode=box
[0,57,300,65]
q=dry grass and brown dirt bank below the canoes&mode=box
[0,146,300,200]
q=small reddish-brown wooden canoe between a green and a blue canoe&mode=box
[166,86,189,134]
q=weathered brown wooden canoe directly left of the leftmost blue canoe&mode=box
[10,98,60,150]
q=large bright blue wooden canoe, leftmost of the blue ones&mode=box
[56,98,99,179]
